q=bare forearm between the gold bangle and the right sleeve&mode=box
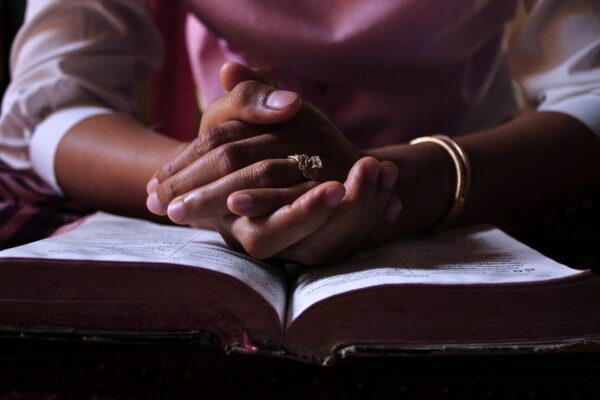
[457,112,600,223]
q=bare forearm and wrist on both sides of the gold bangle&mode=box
[372,112,600,233]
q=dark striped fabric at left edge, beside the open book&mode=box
[0,162,86,249]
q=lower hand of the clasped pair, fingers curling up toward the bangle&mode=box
[214,157,402,265]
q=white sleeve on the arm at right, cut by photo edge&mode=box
[509,0,600,137]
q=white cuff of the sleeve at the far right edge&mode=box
[538,95,600,138]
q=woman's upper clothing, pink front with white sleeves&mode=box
[0,0,600,192]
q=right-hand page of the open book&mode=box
[288,226,580,321]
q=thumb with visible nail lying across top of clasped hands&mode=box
[200,81,302,134]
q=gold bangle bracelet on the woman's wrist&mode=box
[410,135,471,231]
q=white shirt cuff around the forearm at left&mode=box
[29,106,114,194]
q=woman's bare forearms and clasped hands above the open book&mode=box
[56,64,600,264]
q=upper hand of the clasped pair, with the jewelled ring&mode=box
[147,64,363,225]
